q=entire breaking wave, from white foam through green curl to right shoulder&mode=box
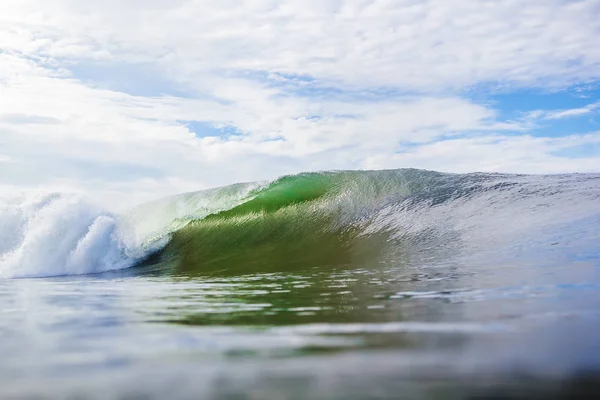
[0,170,600,277]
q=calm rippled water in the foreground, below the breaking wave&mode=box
[0,245,600,398]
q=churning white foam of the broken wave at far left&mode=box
[0,193,136,278]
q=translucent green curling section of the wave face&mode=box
[141,170,445,276]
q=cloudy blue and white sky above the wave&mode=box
[0,0,600,208]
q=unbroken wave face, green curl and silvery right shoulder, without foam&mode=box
[145,170,600,276]
